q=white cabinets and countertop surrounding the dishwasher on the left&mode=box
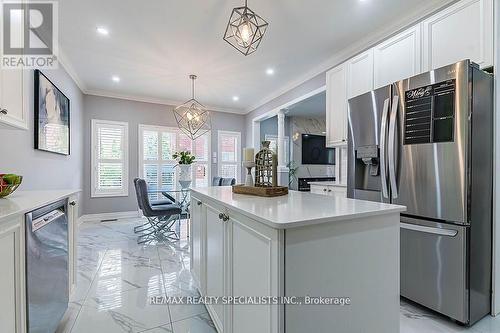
[0,190,80,333]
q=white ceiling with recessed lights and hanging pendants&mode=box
[59,0,449,113]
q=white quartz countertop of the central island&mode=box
[192,186,406,229]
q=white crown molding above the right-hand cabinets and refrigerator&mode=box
[245,0,459,114]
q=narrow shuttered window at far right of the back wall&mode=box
[218,131,241,182]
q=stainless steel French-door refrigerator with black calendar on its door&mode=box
[347,60,493,325]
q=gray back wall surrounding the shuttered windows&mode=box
[83,95,245,214]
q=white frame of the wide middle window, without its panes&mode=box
[137,124,212,190]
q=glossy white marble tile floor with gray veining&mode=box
[58,219,500,333]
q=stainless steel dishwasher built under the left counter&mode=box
[26,200,69,333]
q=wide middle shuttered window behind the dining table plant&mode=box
[139,125,210,200]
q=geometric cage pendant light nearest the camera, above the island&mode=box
[224,0,269,56]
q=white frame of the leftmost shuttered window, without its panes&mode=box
[90,119,129,198]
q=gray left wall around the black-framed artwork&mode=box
[0,64,83,213]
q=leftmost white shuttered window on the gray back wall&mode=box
[91,119,128,197]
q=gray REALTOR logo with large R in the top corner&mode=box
[1,1,59,69]
